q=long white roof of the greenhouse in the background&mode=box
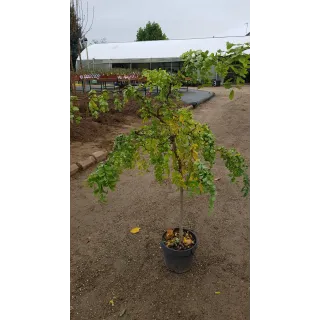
[78,36,250,60]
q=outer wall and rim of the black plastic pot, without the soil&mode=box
[161,228,198,273]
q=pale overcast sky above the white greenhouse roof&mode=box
[82,0,251,42]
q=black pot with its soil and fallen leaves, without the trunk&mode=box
[161,228,198,273]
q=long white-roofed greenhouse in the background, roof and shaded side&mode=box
[77,36,250,77]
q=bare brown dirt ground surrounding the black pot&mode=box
[70,87,250,320]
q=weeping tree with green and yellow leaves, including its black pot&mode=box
[88,42,249,273]
